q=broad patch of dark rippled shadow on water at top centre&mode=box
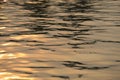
[20,0,99,48]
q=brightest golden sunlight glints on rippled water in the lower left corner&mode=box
[0,50,36,80]
